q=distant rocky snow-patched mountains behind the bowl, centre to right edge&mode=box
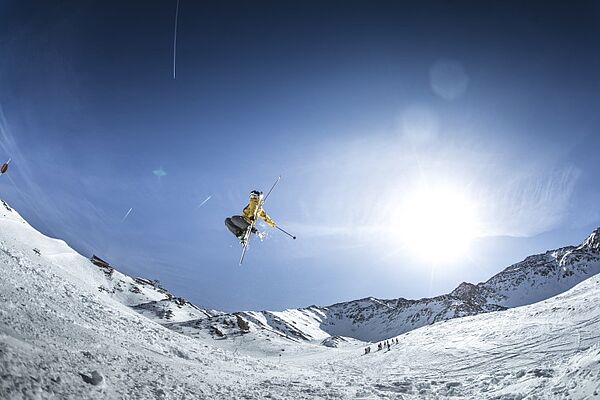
[170,228,600,342]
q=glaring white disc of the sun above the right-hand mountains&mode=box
[398,186,478,263]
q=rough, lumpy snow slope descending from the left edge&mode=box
[0,206,288,400]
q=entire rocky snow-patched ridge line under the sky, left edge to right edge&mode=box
[3,198,600,345]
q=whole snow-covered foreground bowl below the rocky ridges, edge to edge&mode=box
[0,205,600,400]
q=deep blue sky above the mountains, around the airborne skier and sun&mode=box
[0,0,600,310]
